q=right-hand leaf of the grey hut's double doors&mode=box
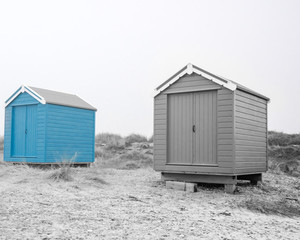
[193,91,217,165]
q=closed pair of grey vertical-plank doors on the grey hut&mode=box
[168,91,217,165]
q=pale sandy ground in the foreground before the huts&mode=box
[0,164,300,239]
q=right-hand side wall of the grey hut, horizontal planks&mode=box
[235,90,267,174]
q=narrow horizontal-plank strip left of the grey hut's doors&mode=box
[153,93,167,171]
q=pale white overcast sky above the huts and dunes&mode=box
[0,0,300,136]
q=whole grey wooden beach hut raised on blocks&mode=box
[154,64,269,192]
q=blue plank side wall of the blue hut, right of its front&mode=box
[46,104,95,163]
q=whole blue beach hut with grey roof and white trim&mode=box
[4,86,97,164]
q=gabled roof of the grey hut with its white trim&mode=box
[155,63,270,101]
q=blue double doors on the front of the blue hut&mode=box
[11,105,37,157]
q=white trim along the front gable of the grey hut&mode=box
[154,63,237,97]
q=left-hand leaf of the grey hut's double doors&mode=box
[167,93,194,164]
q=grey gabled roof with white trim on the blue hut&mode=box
[5,85,97,111]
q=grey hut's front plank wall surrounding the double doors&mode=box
[154,74,234,174]
